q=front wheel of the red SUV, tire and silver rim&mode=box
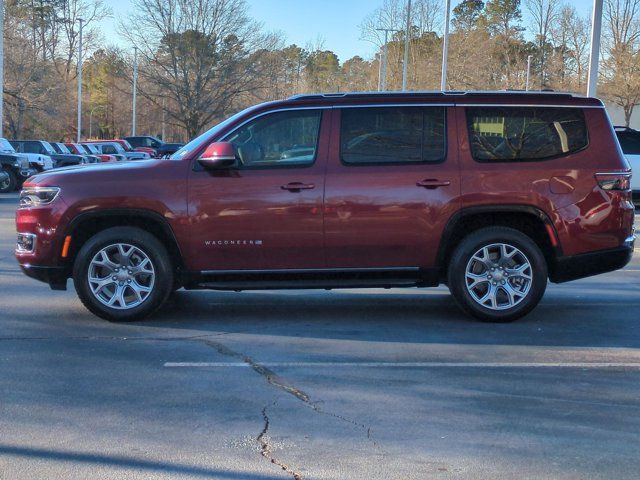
[73,227,173,321]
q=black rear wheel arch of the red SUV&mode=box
[436,205,562,278]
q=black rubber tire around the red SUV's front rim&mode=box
[73,227,174,322]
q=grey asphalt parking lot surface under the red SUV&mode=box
[0,191,640,480]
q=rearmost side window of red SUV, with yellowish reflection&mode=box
[467,107,588,161]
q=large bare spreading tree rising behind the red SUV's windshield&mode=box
[120,0,276,137]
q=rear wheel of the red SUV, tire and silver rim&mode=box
[447,227,547,322]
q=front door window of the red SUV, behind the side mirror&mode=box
[226,110,322,167]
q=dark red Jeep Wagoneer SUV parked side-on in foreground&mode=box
[16,92,634,322]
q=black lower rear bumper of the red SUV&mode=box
[549,235,635,283]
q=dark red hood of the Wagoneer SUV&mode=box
[28,159,161,187]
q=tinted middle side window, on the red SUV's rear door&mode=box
[340,107,445,164]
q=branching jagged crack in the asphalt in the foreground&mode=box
[196,339,384,480]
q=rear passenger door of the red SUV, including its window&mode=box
[325,107,460,268]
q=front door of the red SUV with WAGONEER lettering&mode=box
[182,110,331,271]
